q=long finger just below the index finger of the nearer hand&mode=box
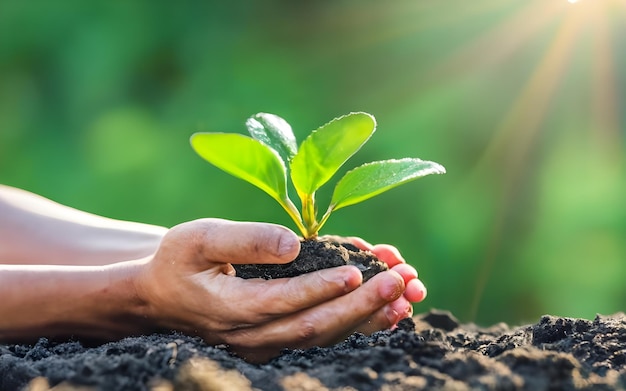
[226,271,404,352]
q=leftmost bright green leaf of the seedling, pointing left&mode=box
[191,133,288,205]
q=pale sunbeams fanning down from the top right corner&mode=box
[450,0,624,315]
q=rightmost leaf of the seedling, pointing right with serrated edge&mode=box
[331,158,446,210]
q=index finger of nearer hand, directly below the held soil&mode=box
[221,266,363,324]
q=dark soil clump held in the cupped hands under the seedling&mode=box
[233,240,388,281]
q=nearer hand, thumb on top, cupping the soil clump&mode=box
[135,219,404,362]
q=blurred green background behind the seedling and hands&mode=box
[0,0,626,325]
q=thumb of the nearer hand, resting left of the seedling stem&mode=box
[170,219,300,264]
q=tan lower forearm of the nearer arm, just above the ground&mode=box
[0,261,154,342]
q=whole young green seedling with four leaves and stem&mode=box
[191,112,446,239]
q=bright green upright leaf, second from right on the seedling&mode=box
[290,113,376,198]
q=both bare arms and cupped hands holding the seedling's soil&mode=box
[0,186,426,362]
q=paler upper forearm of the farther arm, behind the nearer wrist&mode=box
[0,185,167,265]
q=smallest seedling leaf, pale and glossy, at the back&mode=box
[246,113,298,163]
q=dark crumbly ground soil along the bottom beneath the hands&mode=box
[0,311,626,391]
